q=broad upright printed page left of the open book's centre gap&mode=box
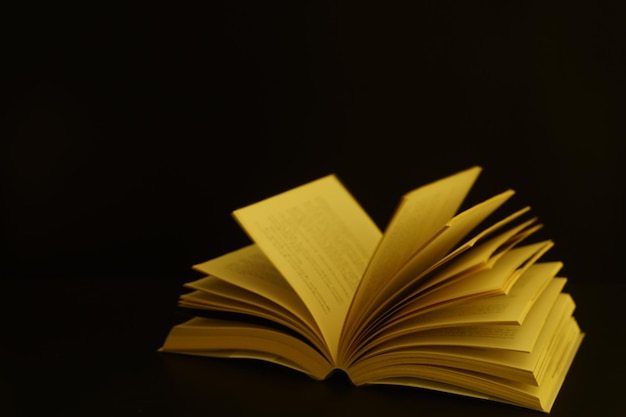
[233,175,382,360]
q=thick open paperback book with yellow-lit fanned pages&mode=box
[160,167,584,412]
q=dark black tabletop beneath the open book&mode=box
[0,279,626,416]
